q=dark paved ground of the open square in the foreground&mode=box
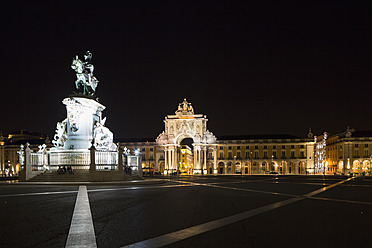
[0,175,372,247]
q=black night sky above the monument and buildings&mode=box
[0,0,372,138]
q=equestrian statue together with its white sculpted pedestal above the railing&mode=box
[52,51,117,151]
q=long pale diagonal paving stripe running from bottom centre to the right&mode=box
[122,178,353,248]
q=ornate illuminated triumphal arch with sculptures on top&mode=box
[156,99,217,174]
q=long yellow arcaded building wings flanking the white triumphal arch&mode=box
[120,135,314,174]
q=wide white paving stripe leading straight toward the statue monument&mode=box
[65,186,97,248]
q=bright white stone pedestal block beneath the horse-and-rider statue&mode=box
[63,96,106,150]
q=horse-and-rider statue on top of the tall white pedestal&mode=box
[71,51,98,97]
